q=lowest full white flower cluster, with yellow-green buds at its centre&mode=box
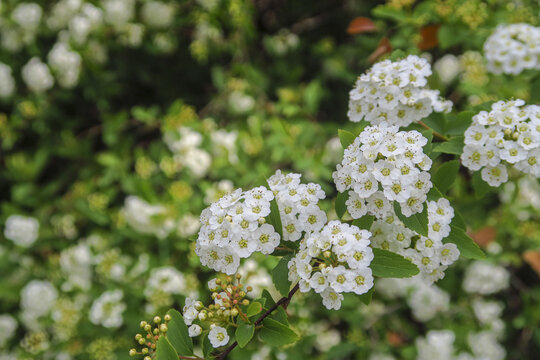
[288,221,373,310]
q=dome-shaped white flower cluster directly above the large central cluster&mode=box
[348,55,452,126]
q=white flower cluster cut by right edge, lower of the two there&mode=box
[461,99,540,186]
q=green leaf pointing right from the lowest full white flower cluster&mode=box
[370,248,419,278]
